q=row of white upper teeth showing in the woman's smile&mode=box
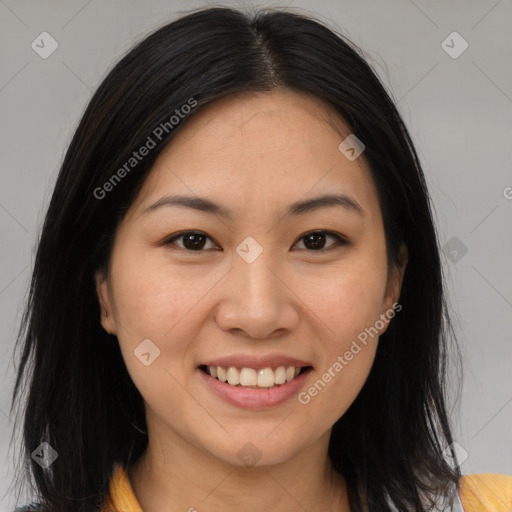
[208,366,301,388]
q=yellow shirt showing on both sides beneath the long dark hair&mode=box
[101,465,512,512]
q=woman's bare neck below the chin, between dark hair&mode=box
[128,431,350,512]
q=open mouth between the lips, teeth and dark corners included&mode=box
[199,363,313,389]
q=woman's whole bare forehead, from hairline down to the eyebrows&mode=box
[127,89,377,224]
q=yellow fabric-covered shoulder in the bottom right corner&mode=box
[460,473,512,512]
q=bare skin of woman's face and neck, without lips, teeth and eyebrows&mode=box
[96,89,406,512]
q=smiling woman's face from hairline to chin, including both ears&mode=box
[97,90,403,465]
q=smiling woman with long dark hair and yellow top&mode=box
[13,8,512,512]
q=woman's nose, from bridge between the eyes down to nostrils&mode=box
[216,251,301,339]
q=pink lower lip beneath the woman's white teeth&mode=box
[197,368,311,409]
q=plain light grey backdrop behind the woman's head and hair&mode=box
[0,0,512,511]
